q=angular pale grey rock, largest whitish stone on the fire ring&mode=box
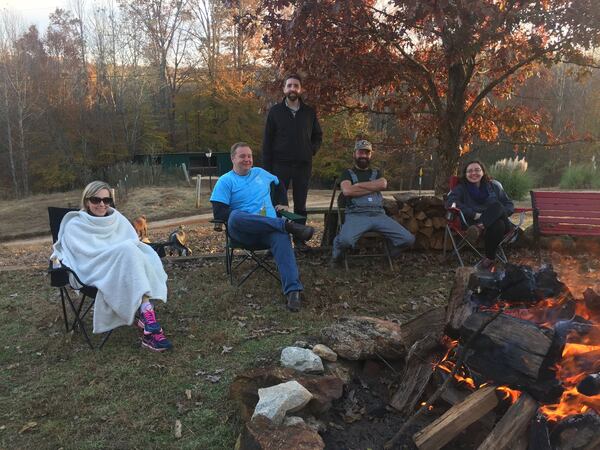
[252,380,313,425]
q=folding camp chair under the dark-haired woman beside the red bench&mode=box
[444,175,531,266]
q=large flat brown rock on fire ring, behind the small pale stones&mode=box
[321,317,406,360]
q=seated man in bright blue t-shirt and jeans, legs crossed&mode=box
[210,142,315,311]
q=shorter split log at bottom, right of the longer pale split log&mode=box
[477,393,538,450]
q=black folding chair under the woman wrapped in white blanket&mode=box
[48,207,112,350]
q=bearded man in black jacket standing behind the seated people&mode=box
[262,75,323,246]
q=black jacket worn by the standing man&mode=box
[262,99,323,171]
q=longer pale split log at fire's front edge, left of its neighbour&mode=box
[413,386,499,450]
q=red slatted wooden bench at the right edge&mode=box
[531,191,600,248]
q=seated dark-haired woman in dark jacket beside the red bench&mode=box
[446,161,515,269]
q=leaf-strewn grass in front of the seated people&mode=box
[0,254,451,449]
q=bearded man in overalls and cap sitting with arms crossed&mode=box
[332,139,415,264]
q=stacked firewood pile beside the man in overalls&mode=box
[385,193,450,250]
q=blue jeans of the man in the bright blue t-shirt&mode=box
[228,210,303,294]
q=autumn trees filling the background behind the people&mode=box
[0,0,600,197]
